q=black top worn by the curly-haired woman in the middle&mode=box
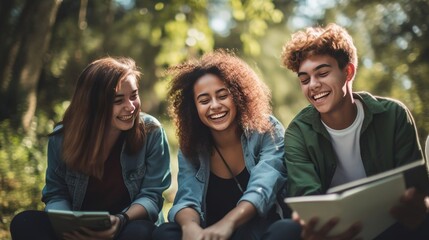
[206,168,250,226]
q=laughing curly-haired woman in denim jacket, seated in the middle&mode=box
[154,50,286,240]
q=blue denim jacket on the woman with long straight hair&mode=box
[42,113,171,222]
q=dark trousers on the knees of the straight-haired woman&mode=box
[10,210,155,240]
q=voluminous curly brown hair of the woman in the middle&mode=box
[168,49,272,164]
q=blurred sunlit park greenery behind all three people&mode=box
[0,0,429,239]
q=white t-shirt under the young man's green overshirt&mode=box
[322,99,366,187]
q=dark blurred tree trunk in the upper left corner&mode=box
[0,0,61,131]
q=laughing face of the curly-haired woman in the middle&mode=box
[194,74,237,132]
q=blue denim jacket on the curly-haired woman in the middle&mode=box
[168,116,286,225]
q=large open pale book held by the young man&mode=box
[285,160,429,240]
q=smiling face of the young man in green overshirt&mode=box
[298,55,354,118]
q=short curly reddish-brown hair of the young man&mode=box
[281,23,358,72]
